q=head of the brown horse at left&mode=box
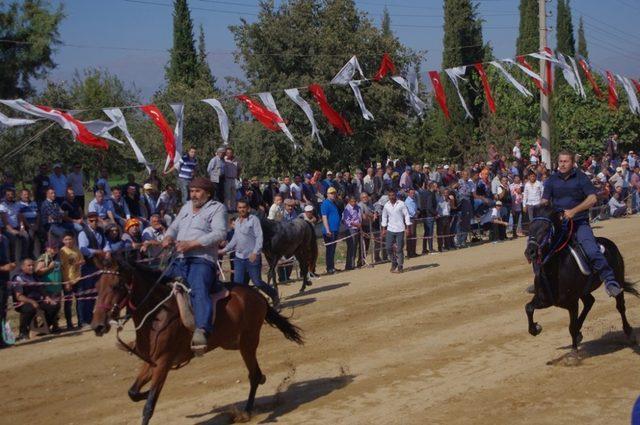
[91,253,133,336]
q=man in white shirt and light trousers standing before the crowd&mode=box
[380,190,411,273]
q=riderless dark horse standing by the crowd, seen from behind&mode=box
[260,218,318,292]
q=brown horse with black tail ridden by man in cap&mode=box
[91,254,303,425]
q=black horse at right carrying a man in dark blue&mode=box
[524,206,640,355]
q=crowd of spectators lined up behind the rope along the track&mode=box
[0,135,640,344]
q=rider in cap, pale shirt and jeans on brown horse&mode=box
[162,177,227,351]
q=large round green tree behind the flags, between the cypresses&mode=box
[230,0,418,176]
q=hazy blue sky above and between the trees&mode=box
[50,0,640,98]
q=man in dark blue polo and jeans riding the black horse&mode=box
[542,151,622,297]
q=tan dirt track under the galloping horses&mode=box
[0,217,640,424]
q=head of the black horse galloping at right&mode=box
[524,205,562,263]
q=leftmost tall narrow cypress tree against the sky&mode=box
[165,0,199,87]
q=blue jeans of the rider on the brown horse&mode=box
[167,257,219,333]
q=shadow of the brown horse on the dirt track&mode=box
[187,375,355,425]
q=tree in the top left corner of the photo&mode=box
[0,0,64,99]
